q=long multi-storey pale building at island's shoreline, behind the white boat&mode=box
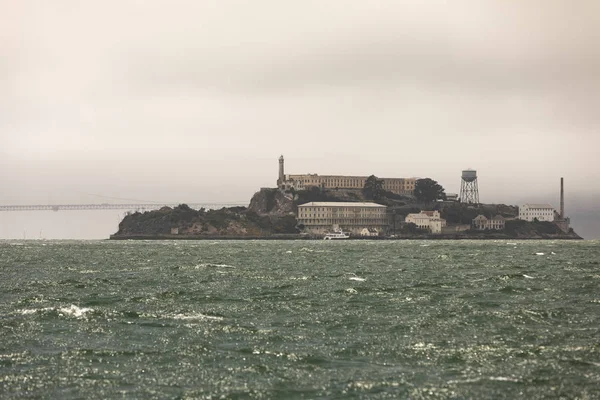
[298,201,388,235]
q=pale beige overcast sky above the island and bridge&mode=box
[0,0,600,237]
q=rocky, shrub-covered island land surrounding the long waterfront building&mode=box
[110,187,581,240]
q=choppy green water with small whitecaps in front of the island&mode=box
[0,241,600,399]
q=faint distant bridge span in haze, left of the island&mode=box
[0,202,247,211]
